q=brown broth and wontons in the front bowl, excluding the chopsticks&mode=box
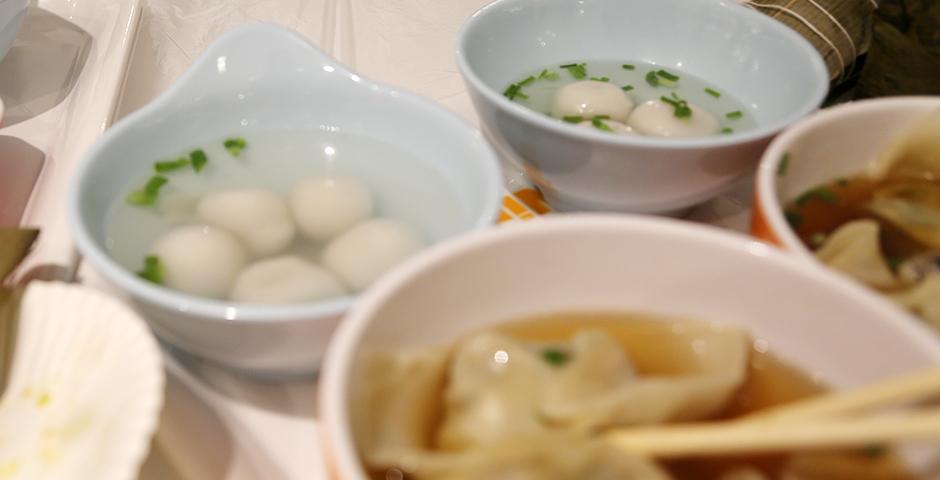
[353,312,908,480]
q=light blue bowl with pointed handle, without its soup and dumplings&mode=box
[68,24,501,375]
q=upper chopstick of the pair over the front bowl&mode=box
[740,367,940,422]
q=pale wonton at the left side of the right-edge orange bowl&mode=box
[816,220,897,288]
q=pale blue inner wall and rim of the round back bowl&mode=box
[457,0,828,148]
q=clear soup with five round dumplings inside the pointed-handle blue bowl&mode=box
[106,130,463,303]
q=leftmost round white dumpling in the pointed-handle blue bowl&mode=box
[152,225,248,298]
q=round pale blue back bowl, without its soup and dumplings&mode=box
[457,0,829,213]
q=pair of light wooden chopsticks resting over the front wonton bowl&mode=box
[606,367,940,458]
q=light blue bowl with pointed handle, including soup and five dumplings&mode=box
[69,24,501,375]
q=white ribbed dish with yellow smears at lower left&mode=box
[0,282,164,480]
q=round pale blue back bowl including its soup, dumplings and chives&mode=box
[457,0,828,213]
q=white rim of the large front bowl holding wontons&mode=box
[317,214,940,479]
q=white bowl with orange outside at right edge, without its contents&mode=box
[751,96,940,261]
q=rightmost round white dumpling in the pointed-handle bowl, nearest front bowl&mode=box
[323,218,424,291]
